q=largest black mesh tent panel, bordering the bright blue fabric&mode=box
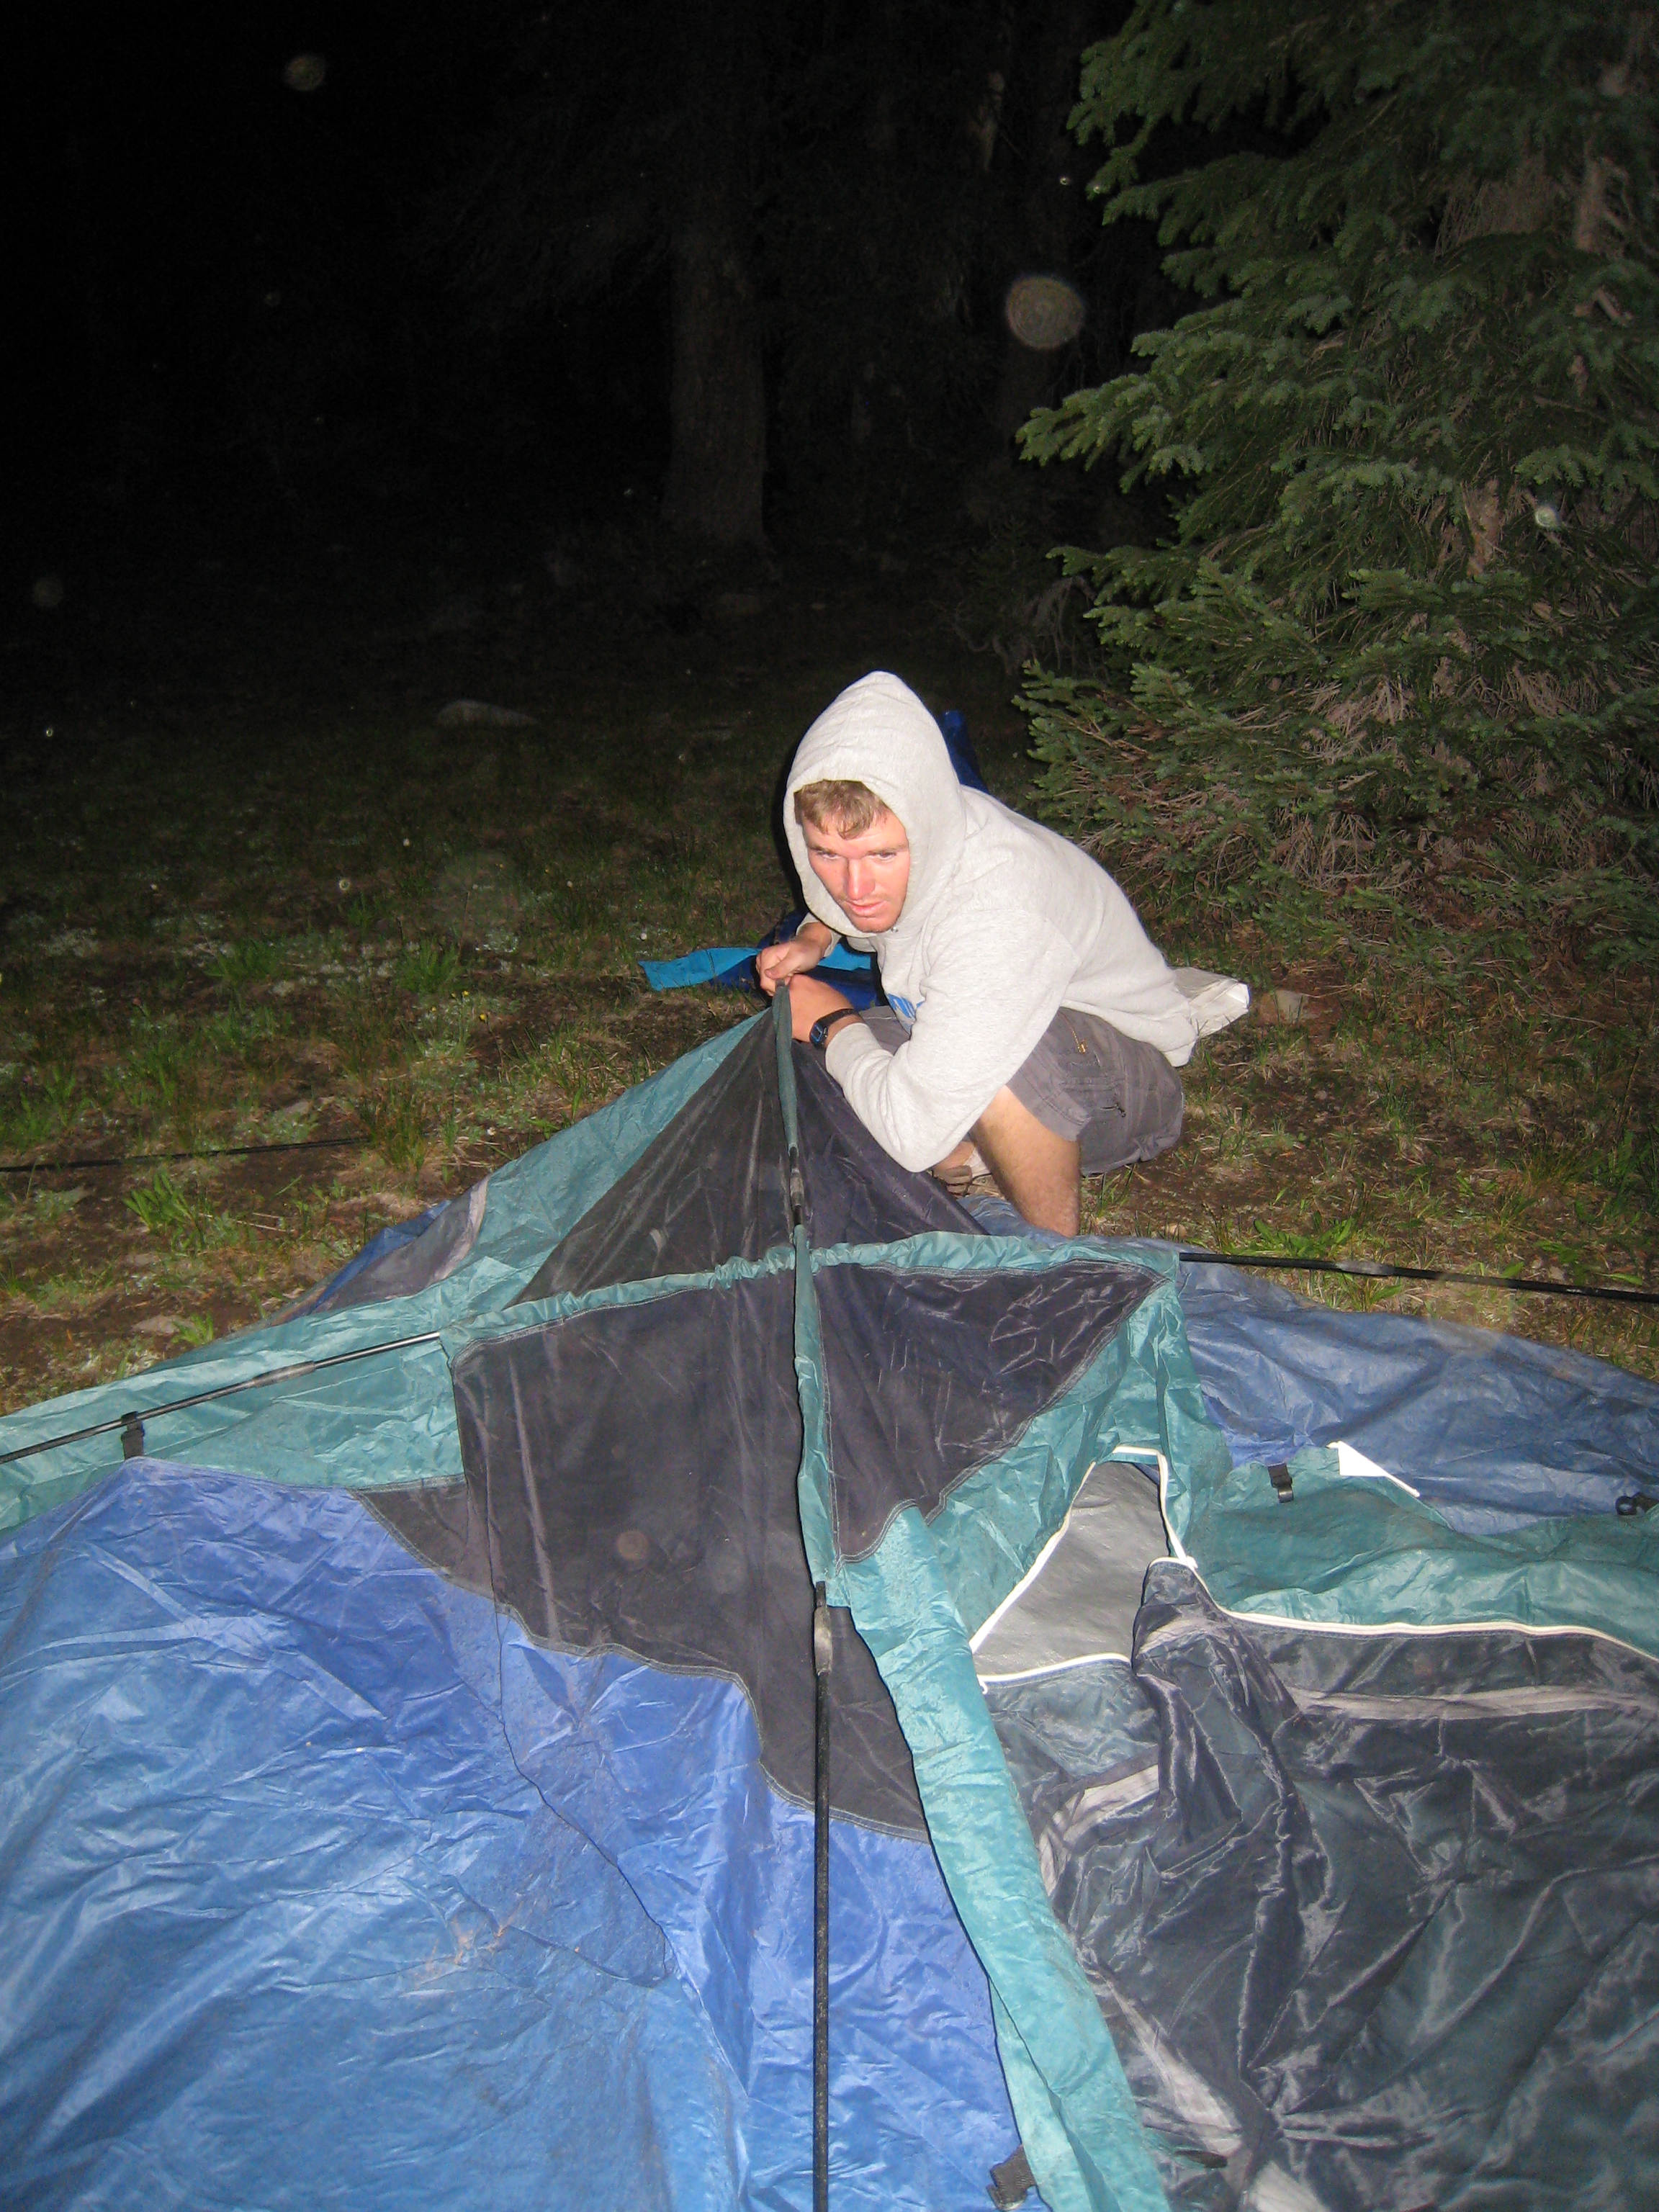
[397,1274,922,1834]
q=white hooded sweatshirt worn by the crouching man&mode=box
[783,673,1250,1168]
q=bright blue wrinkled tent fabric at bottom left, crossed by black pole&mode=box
[0,1460,1015,2212]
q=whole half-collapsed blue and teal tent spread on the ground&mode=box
[0,1015,1659,2212]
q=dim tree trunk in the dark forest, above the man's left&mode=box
[662,190,765,547]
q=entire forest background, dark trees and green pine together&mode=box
[0,0,1659,942]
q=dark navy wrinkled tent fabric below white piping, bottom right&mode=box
[986,1562,1659,2212]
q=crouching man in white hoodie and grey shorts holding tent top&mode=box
[759,673,1250,1236]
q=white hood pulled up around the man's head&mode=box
[783,668,966,938]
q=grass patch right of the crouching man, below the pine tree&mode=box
[1090,931,1659,1376]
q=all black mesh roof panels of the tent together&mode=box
[387,1022,1153,1832]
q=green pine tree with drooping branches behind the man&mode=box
[1024,0,1659,958]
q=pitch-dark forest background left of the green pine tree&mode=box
[0,0,1170,553]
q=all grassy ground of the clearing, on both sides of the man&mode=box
[0,519,1659,1409]
